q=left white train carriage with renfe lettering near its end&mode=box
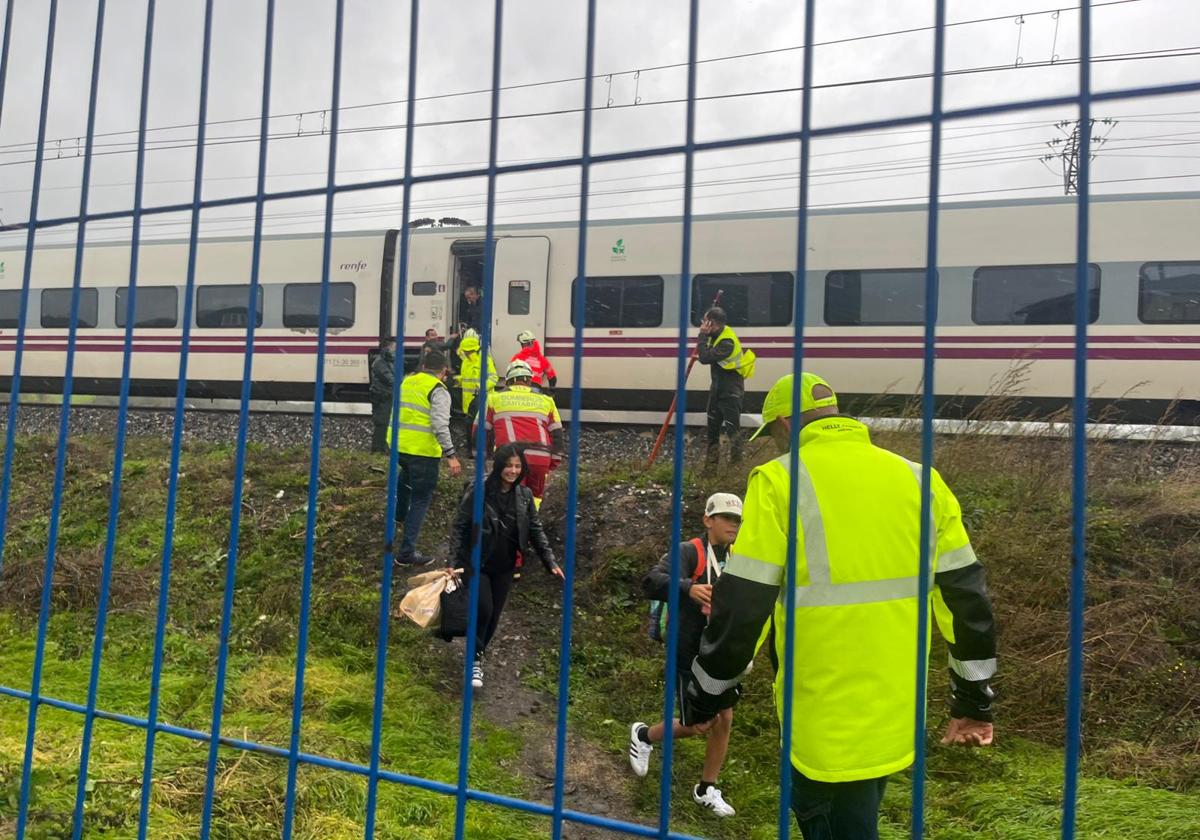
[0,232,397,401]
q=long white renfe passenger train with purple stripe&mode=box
[0,193,1200,425]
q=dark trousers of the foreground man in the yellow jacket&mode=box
[792,767,888,840]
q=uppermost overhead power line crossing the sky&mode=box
[0,0,1141,160]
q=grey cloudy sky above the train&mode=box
[0,0,1200,246]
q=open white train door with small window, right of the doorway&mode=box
[492,236,550,367]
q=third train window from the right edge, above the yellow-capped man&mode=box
[824,269,925,326]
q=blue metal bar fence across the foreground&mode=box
[0,0,1200,840]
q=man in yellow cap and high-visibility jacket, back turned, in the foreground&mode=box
[685,373,996,840]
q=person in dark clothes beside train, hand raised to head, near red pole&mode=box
[696,306,755,472]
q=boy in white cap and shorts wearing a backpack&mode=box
[629,493,742,817]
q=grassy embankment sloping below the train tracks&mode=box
[0,429,1200,840]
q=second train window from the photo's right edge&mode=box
[971,263,1100,324]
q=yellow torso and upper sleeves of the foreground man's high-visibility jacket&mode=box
[725,416,977,782]
